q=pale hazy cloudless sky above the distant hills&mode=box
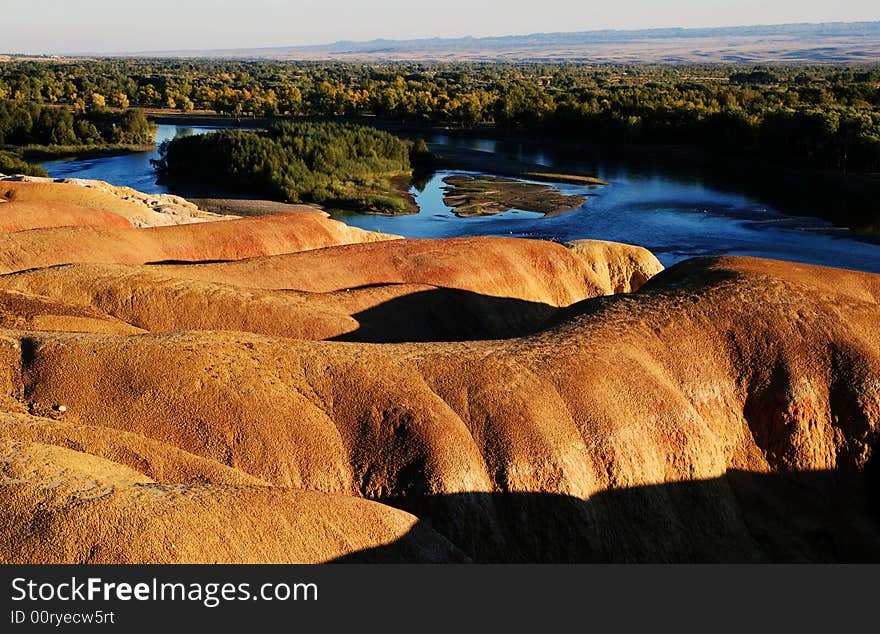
[0,0,880,53]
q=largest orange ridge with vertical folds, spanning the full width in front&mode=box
[3,258,880,560]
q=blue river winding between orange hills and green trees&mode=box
[43,125,880,273]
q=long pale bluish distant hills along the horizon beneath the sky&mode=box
[143,22,880,63]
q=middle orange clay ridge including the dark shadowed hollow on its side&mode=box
[0,238,662,341]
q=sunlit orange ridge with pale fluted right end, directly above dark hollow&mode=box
[153,238,663,306]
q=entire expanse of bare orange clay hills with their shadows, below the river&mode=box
[0,175,880,563]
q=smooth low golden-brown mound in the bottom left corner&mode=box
[0,428,467,563]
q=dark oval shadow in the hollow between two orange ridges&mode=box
[326,288,559,343]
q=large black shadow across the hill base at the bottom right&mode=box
[328,458,880,563]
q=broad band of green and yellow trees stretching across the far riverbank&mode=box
[0,59,880,171]
